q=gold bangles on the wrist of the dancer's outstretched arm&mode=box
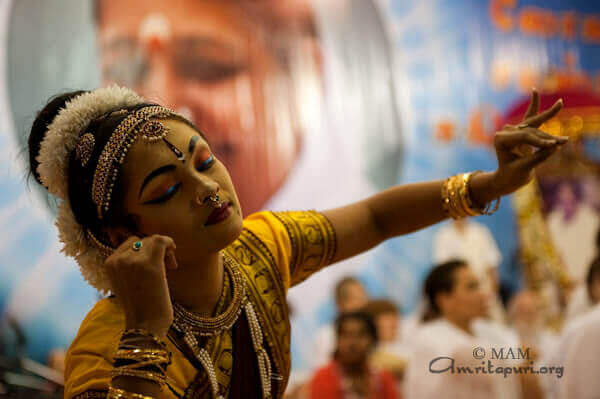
[442,171,500,219]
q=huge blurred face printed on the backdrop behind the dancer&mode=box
[98,0,299,213]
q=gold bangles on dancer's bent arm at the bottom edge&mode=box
[107,330,171,399]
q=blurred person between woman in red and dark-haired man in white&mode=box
[365,299,409,380]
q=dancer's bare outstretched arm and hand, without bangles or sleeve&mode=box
[323,91,567,262]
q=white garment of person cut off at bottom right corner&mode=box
[548,304,600,399]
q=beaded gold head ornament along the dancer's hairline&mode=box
[92,105,185,219]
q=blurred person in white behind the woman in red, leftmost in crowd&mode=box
[310,276,369,371]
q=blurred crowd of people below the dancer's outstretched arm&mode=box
[287,220,600,399]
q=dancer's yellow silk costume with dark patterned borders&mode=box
[65,211,336,399]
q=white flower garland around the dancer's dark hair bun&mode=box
[36,85,146,292]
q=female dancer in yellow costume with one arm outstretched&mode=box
[29,86,566,398]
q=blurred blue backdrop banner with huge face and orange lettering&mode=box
[0,0,600,384]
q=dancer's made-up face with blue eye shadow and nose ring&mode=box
[122,120,242,258]
